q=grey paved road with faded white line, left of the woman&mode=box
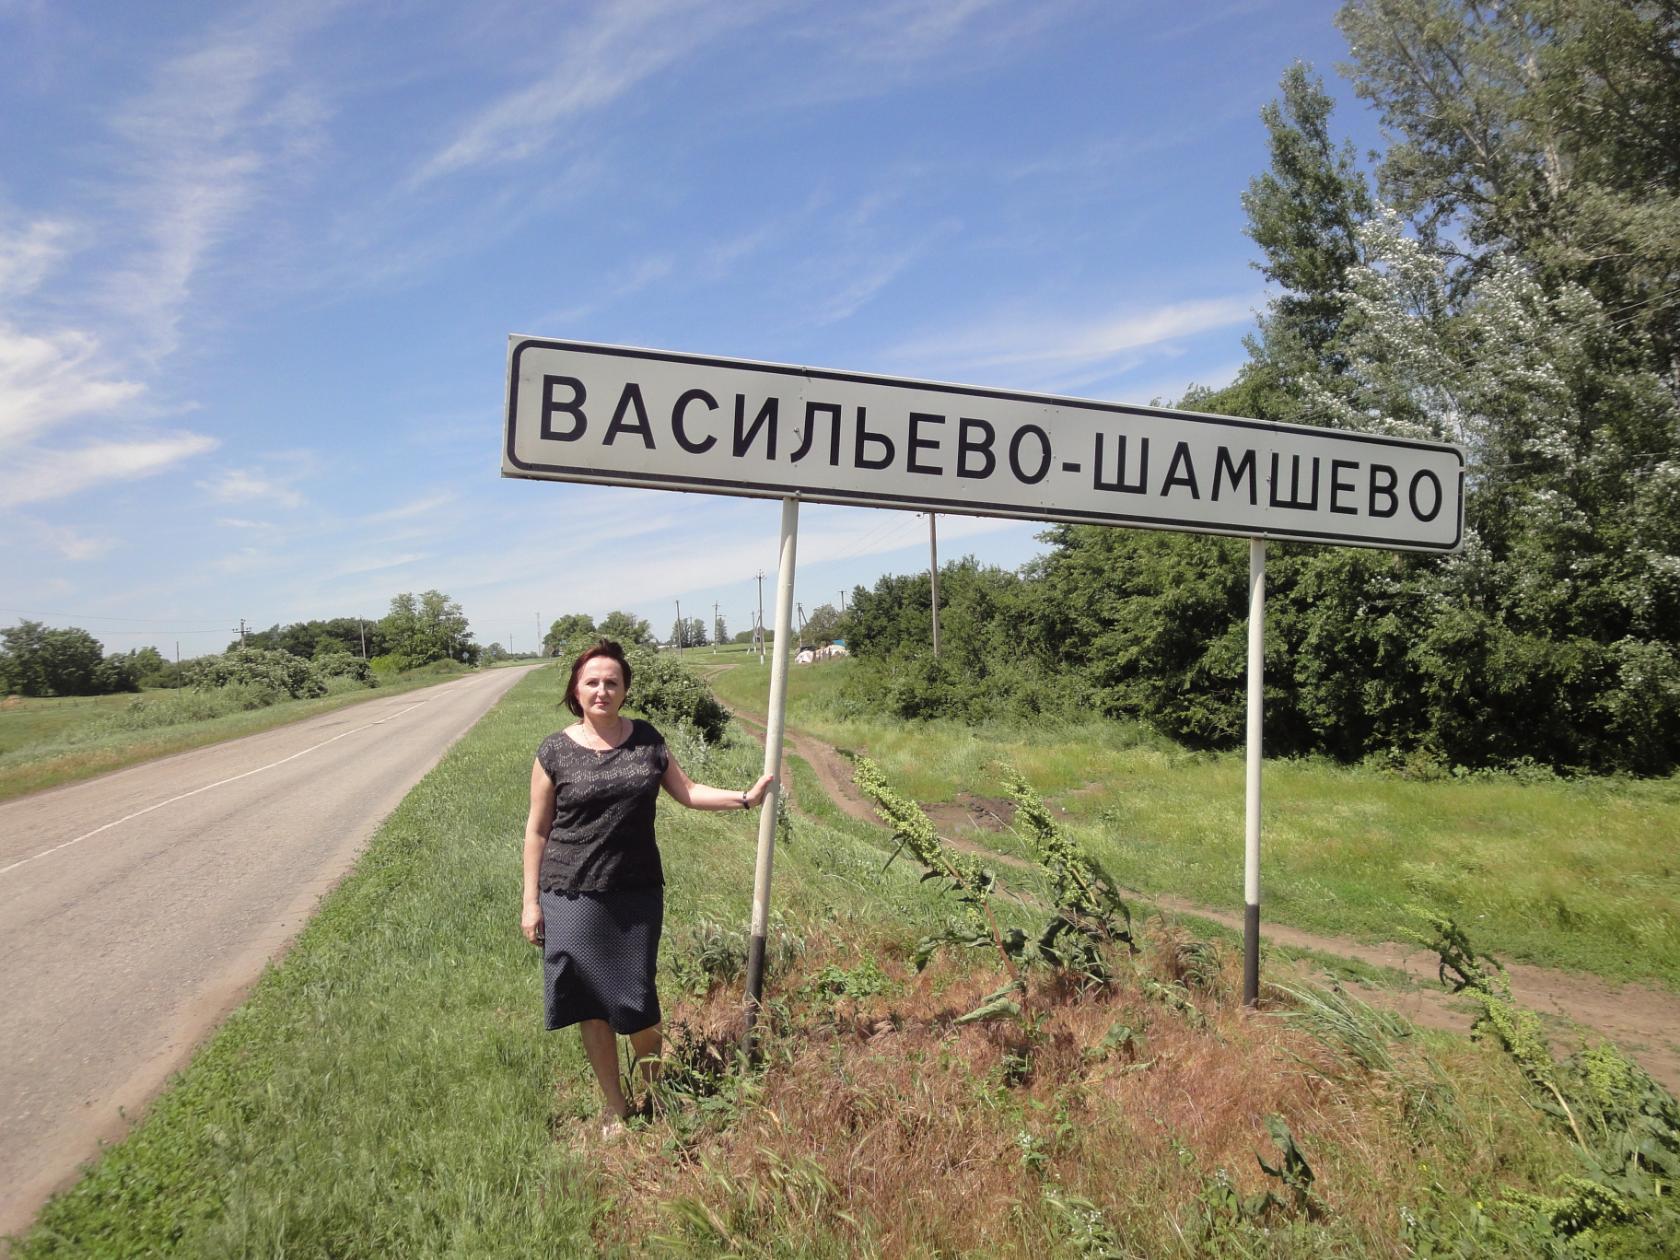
[0,667,534,1235]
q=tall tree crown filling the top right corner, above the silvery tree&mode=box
[1337,0,1680,381]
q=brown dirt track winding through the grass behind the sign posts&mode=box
[734,692,1680,1094]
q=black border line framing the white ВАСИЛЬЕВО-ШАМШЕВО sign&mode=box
[502,334,1465,553]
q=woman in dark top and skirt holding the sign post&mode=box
[521,638,774,1136]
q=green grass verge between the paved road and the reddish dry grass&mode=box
[13,672,960,1260]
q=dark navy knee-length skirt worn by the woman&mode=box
[541,887,665,1033]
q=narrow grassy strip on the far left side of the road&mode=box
[0,665,487,801]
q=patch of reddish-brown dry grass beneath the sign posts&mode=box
[581,927,1572,1257]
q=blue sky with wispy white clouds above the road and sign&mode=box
[0,0,1376,657]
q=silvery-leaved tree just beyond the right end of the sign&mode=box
[1309,215,1680,769]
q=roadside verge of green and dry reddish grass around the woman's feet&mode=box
[15,674,1666,1260]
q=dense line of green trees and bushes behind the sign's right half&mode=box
[847,0,1680,773]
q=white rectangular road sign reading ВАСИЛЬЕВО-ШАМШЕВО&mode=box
[502,336,1463,551]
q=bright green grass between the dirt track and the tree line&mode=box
[701,662,1680,988]
